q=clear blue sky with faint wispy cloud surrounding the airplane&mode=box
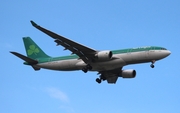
[0,0,180,113]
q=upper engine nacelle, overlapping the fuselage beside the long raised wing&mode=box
[95,50,113,60]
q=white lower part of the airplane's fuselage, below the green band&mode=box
[35,50,170,71]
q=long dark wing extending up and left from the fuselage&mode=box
[31,21,97,64]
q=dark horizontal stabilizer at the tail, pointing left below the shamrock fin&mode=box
[10,52,38,65]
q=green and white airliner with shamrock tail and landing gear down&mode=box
[10,21,171,84]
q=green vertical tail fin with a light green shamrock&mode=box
[23,37,50,59]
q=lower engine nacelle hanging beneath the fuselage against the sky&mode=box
[121,70,136,78]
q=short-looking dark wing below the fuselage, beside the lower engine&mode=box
[99,68,122,84]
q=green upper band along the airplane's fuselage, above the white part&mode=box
[24,46,166,64]
